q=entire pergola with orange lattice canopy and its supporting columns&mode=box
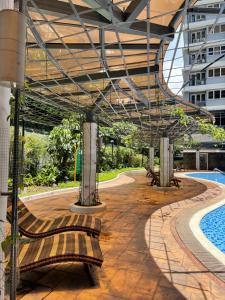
[0,0,223,299]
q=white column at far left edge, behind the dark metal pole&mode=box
[0,0,14,300]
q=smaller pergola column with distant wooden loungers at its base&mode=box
[160,137,170,187]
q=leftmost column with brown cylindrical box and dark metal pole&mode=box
[0,0,26,300]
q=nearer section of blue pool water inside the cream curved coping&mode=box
[200,205,225,253]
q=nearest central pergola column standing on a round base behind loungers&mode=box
[80,113,97,206]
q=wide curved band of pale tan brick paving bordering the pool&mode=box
[145,173,225,300]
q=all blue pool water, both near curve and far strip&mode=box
[187,172,225,253]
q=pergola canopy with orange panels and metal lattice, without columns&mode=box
[18,0,211,145]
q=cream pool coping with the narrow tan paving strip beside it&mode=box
[176,174,225,287]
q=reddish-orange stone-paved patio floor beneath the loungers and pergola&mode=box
[14,172,225,300]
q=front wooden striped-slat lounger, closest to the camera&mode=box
[6,232,103,283]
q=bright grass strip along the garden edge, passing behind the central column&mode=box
[19,168,143,197]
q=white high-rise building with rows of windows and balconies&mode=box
[183,0,225,128]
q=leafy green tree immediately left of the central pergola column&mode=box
[48,115,80,181]
